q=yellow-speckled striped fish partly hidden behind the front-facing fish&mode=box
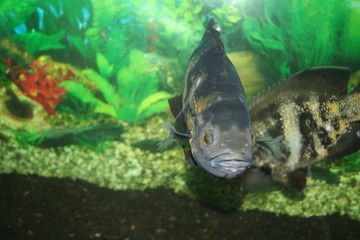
[239,66,360,190]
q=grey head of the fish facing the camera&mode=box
[189,101,254,178]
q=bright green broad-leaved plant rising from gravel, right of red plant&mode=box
[62,50,171,122]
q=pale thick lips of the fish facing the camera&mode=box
[210,153,250,170]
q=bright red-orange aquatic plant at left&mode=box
[5,58,75,117]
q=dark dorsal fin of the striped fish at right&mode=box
[249,66,351,108]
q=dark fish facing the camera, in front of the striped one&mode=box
[159,18,276,179]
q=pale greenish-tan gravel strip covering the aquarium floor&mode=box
[0,117,360,220]
